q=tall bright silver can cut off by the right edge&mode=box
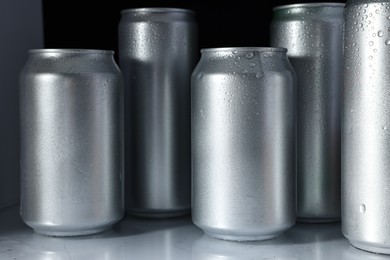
[341,0,390,254]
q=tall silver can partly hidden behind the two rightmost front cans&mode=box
[270,3,345,222]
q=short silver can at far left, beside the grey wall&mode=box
[19,49,124,236]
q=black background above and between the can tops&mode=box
[42,0,345,61]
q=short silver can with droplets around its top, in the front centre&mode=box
[191,47,296,240]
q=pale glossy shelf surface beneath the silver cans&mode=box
[0,206,390,260]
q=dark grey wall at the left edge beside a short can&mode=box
[0,0,43,208]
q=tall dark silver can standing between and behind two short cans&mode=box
[118,8,199,217]
